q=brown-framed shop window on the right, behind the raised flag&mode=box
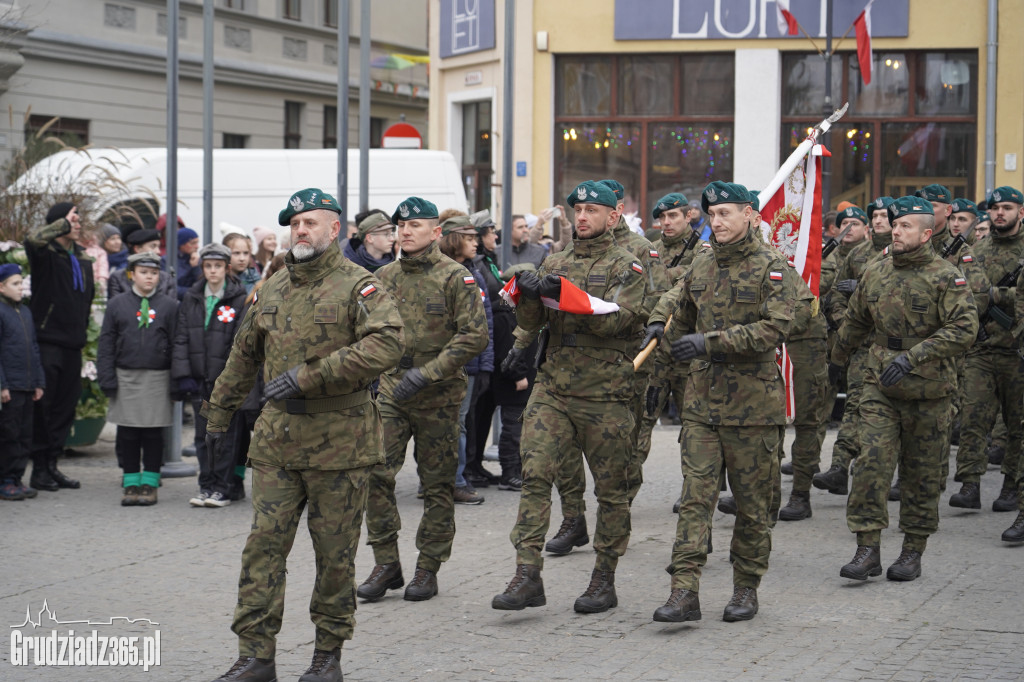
[782,51,978,206]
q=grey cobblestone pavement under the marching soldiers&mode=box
[0,419,1024,681]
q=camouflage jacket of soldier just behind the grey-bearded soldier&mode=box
[377,242,488,408]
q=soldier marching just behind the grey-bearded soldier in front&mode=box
[357,197,487,601]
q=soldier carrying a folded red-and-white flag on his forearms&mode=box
[492,181,648,613]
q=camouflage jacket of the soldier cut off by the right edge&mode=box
[959,229,1024,353]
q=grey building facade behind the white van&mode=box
[0,0,429,160]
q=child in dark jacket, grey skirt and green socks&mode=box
[96,251,178,507]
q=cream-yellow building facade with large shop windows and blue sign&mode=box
[429,0,1024,216]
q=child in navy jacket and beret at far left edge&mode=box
[0,263,46,500]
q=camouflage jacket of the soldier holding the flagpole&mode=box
[651,228,797,426]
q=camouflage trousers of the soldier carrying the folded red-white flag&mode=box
[509,384,635,570]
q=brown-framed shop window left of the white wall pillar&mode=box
[553,53,735,220]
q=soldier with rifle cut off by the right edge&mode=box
[949,186,1024,512]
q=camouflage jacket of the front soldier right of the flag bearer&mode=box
[831,241,978,400]
